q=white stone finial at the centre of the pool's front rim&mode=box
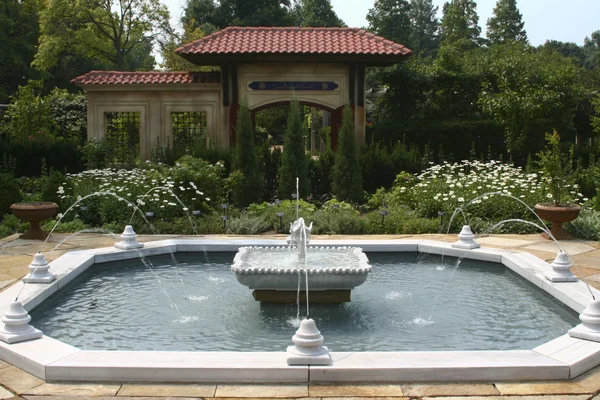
[287,319,332,365]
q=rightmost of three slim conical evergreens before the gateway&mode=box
[331,105,363,203]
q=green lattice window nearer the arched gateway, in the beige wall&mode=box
[171,111,206,151]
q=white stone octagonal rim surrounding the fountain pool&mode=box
[0,239,600,383]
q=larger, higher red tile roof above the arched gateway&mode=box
[176,26,412,56]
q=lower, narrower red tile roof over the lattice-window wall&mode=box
[71,71,221,85]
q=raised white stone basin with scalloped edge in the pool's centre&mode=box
[231,246,371,291]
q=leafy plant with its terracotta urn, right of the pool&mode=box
[535,131,581,240]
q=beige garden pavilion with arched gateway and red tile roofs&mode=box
[72,26,412,159]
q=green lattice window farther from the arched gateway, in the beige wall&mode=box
[105,112,140,164]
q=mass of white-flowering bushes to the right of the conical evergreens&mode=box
[378,160,582,231]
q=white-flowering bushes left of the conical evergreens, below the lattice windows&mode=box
[57,156,227,230]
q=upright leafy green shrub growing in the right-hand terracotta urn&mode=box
[537,131,574,207]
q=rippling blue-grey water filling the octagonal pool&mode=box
[31,253,579,351]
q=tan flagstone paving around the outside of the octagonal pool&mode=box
[0,234,600,400]
